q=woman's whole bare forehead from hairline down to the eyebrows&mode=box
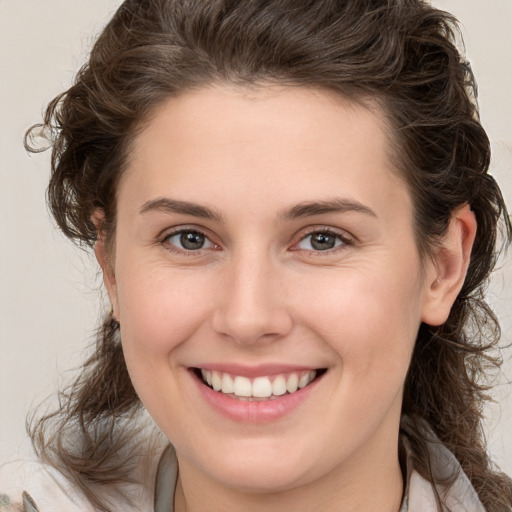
[120,86,408,222]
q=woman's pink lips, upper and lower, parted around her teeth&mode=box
[190,364,321,424]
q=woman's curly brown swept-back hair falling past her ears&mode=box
[26,0,512,512]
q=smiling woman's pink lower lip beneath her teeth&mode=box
[190,371,321,423]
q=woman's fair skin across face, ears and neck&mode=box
[96,86,476,512]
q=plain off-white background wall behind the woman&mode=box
[0,0,512,474]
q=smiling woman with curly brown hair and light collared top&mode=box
[3,0,512,512]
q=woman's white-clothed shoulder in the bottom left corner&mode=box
[0,460,94,512]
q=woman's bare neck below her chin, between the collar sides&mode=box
[175,432,404,512]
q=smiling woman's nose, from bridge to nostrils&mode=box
[213,253,293,345]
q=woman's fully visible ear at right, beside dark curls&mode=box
[421,205,477,325]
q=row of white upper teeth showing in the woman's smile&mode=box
[201,370,316,398]
